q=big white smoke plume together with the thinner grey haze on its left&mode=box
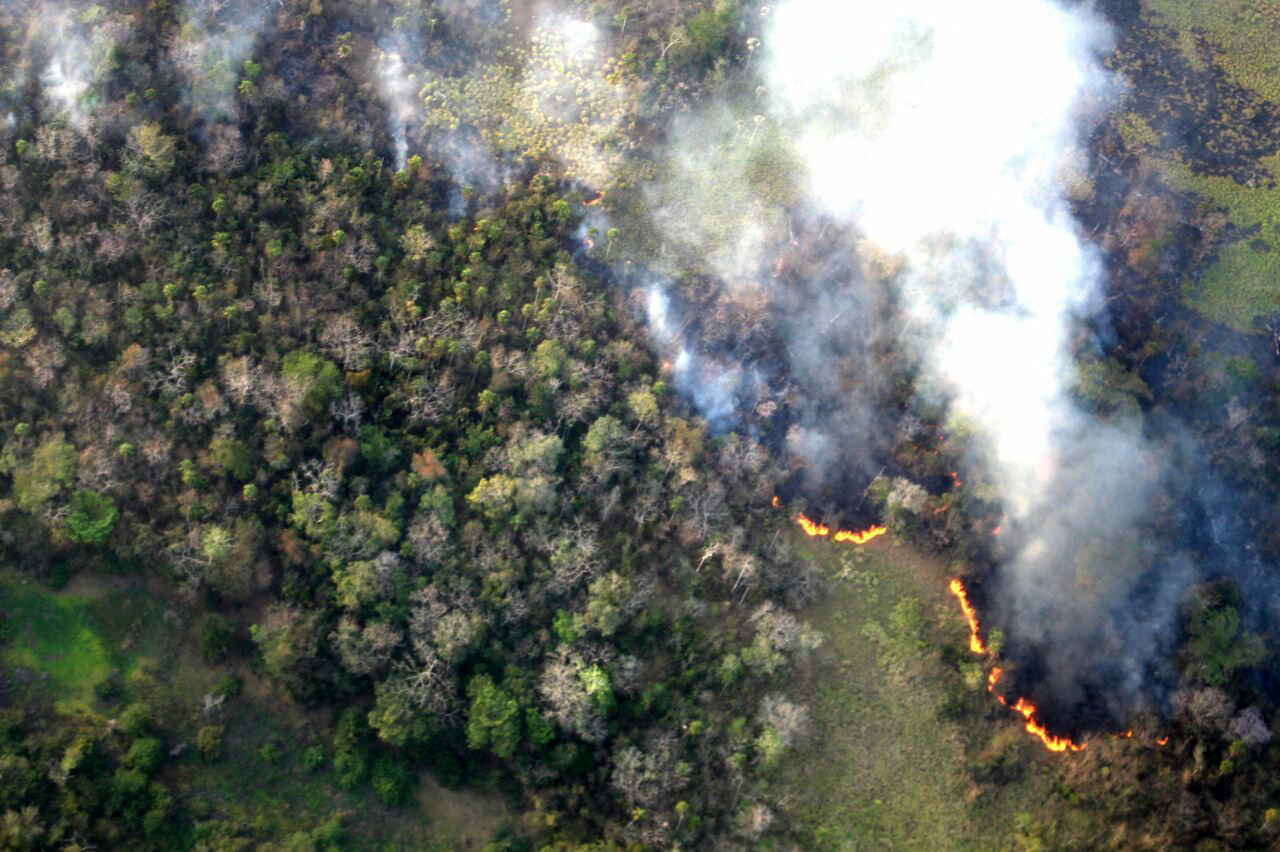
[619,0,1218,719]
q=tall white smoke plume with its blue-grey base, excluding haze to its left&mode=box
[764,0,1177,718]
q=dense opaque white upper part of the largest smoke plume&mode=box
[764,0,1106,516]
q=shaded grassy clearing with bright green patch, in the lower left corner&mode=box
[0,572,516,849]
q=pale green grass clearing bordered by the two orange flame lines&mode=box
[782,539,1052,849]
